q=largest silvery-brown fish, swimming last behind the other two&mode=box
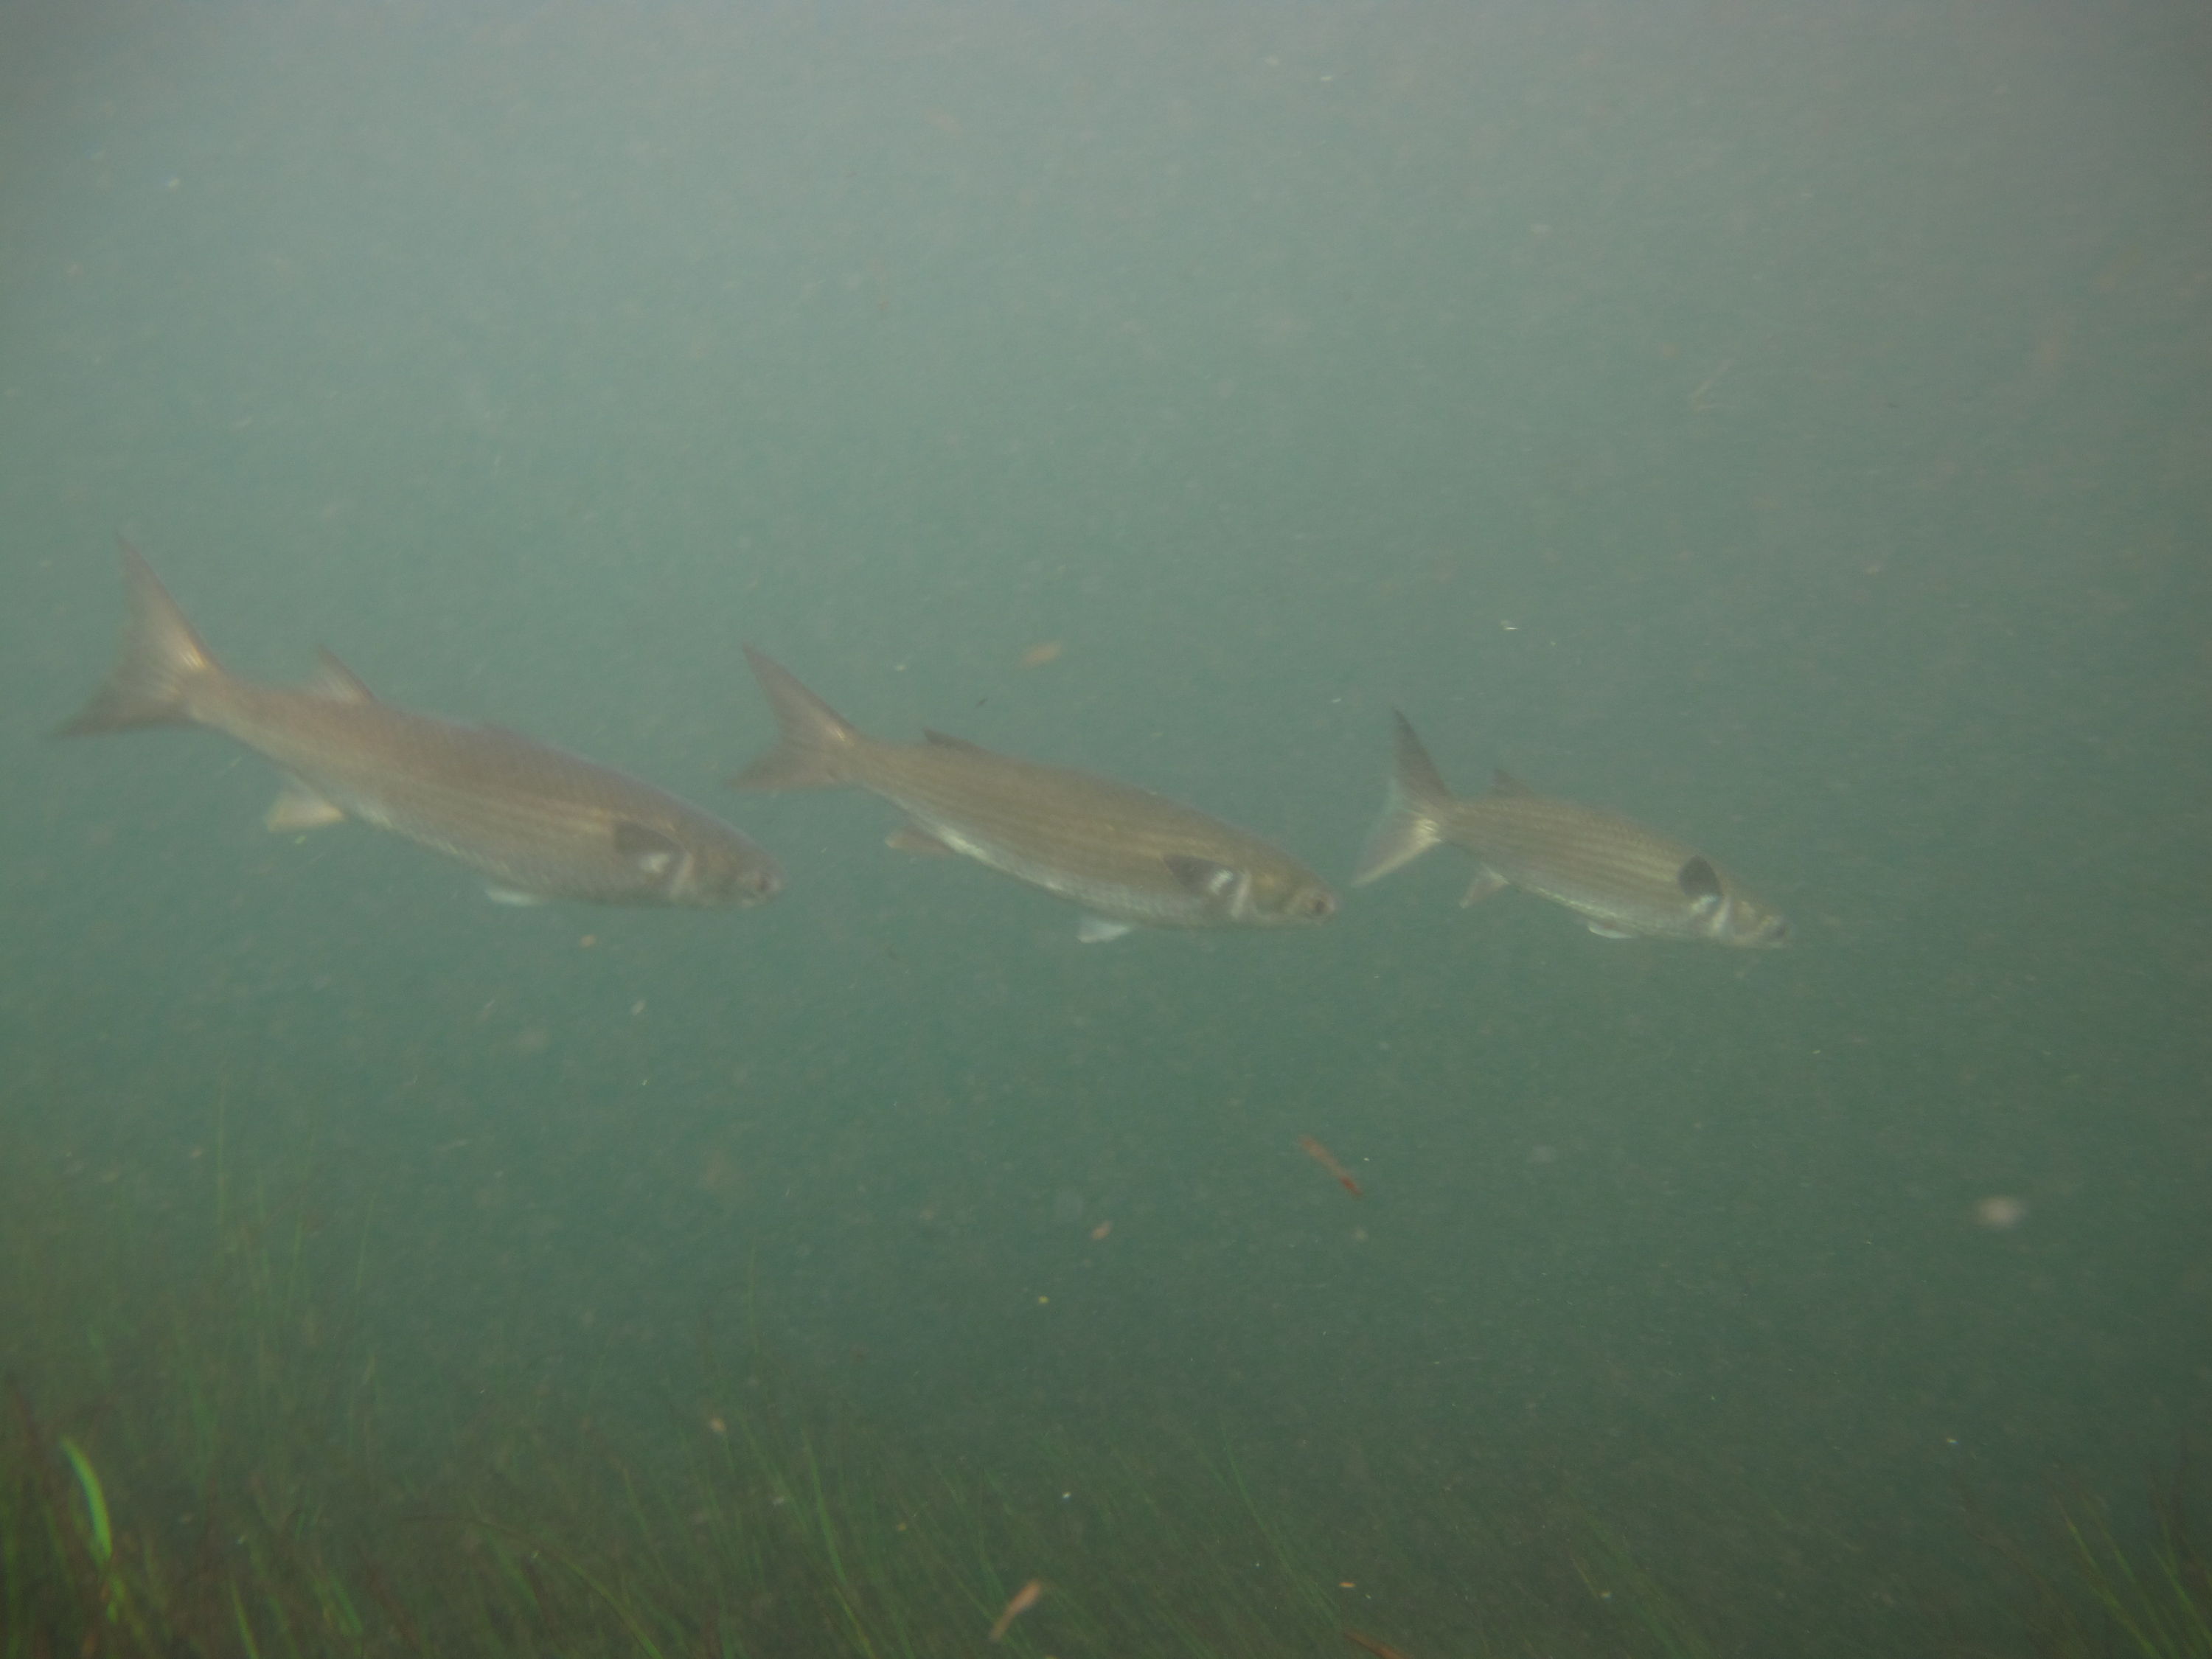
[60,544,783,909]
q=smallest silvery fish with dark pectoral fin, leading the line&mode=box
[1354,714,1790,949]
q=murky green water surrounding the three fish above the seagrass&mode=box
[0,0,2212,1659]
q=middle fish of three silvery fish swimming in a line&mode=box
[732,646,1336,942]
